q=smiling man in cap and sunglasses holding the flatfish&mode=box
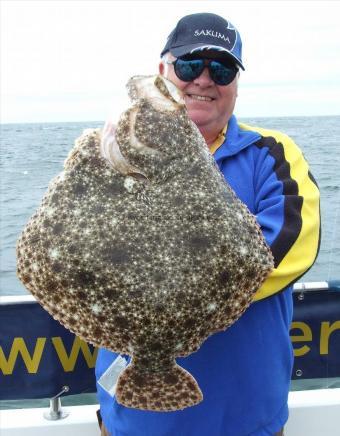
[96,13,320,436]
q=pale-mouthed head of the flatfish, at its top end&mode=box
[104,75,205,179]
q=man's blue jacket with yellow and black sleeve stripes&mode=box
[96,116,320,436]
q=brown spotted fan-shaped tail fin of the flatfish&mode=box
[115,362,203,412]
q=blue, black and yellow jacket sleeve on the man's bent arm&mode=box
[254,129,320,301]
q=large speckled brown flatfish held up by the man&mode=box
[17,76,273,411]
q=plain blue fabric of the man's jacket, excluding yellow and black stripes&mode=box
[96,117,293,436]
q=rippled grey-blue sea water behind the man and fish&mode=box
[0,116,340,408]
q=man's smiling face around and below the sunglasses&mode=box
[159,54,238,135]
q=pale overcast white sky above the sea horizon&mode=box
[0,0,340,123]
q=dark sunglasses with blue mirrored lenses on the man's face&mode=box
[167,58,238,86]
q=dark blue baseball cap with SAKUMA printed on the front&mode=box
[161,13,244,70]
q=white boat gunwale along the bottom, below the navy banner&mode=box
[0,389,340,436]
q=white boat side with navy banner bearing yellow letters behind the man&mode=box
[0,280,340,436]
